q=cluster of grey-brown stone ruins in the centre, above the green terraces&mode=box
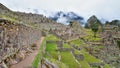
[49,28,80,41]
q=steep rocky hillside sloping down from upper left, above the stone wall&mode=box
[0,4,65,30]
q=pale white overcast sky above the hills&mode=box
[0,0,120,21]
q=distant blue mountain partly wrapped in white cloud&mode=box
[49,11,84,25]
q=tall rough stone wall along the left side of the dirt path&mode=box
[0,19,41,67]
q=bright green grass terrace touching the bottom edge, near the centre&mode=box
[60,52,80,68]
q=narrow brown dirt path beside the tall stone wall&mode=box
[10,37,44,68]
